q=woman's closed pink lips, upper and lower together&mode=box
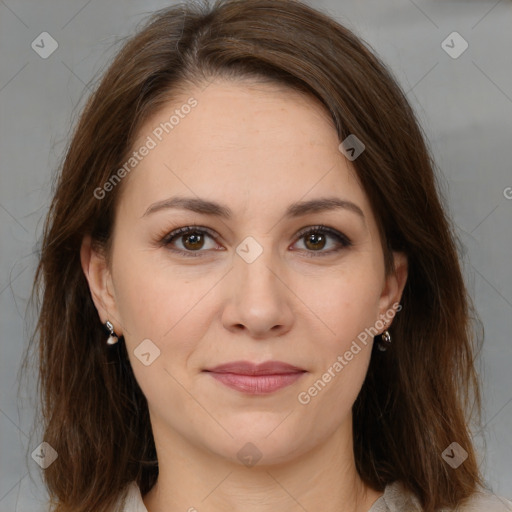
[204,361,306,395]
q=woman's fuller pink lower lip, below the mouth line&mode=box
[208,372,305,395]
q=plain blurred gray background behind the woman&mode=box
[0,0,512,512]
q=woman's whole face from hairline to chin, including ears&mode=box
[82,80,406,464]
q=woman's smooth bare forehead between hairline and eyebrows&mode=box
[117,80,368,222]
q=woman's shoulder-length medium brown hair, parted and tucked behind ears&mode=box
[27,0,482,512]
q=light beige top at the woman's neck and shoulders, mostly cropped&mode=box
[116,481,512,512]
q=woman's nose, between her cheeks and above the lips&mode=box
[222,244,295,339]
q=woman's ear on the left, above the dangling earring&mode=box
[80,235,123,336]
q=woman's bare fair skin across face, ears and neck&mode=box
[82,79,407,512]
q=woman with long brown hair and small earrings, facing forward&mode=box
[29,0,512,512]
